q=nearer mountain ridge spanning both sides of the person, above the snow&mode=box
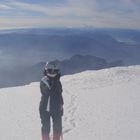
[0,55,124,87]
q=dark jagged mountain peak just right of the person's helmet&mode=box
[58,55,108,75]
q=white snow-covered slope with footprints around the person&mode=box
[0,66,140,140]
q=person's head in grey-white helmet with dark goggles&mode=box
[45,61,60,78]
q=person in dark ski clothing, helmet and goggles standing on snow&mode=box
[39,62,64,140]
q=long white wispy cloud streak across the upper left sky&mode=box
[9,1,93,17]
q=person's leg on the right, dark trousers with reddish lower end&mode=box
[52,114,62,140]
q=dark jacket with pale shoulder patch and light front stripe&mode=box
[39,76,64,114]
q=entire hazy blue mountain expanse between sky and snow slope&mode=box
[0,28,140,87]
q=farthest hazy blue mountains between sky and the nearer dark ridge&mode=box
[0,28,140,69]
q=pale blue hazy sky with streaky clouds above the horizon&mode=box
[0,0,140,29]
